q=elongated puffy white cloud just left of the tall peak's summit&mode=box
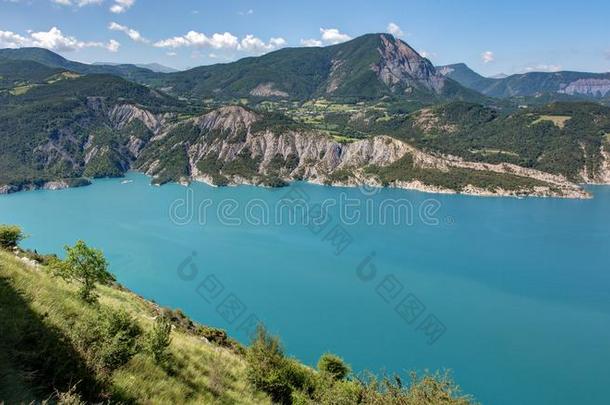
[154,31,286,54]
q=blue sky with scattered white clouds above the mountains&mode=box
[0,0,610,75]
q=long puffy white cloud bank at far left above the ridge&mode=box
[0,27,121,52]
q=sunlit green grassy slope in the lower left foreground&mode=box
[0,251,269,404]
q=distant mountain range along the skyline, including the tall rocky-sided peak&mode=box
[0,38,610,103]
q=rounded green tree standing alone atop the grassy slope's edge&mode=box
[53,240,114,303]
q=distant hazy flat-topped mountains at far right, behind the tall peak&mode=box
[438,63,610,100]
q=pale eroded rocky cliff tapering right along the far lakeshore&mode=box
[133,107,588,198]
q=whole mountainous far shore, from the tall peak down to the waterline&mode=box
[0,34,610,197]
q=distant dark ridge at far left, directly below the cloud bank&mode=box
[0,48,155,81]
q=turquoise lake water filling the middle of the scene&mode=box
[0,173,610,405]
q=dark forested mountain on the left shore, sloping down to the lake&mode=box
[0,61,185,191]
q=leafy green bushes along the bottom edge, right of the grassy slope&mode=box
[246,326,472,405]
